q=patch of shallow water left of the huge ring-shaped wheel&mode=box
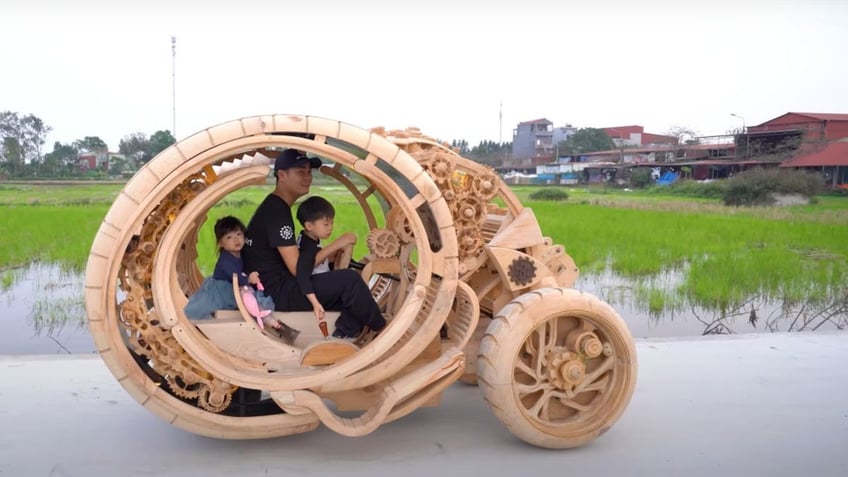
[0,264,95,354]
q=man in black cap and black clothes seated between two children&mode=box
[242,149,386,340]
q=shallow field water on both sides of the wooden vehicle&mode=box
[0,264,848,354]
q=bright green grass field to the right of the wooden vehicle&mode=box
[517,189,848,311]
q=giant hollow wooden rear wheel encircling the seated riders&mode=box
[85,115,458,438]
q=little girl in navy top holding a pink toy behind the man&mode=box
[184,216,299,341]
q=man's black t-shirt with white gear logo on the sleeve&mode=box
[241,194,297,296]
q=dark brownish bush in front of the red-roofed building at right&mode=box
[722,168,823,206]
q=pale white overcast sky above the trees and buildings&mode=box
[0,0,848,152]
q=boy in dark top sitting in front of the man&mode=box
[297,196,361,338]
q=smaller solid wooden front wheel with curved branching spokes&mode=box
[477,288,636,449]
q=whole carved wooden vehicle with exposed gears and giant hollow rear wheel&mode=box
[85,115,636,448]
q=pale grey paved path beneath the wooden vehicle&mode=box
[0,333,848,477]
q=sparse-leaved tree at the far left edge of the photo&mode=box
[0,111,52,173]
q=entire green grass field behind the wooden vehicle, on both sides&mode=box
[0,178,848,313]
